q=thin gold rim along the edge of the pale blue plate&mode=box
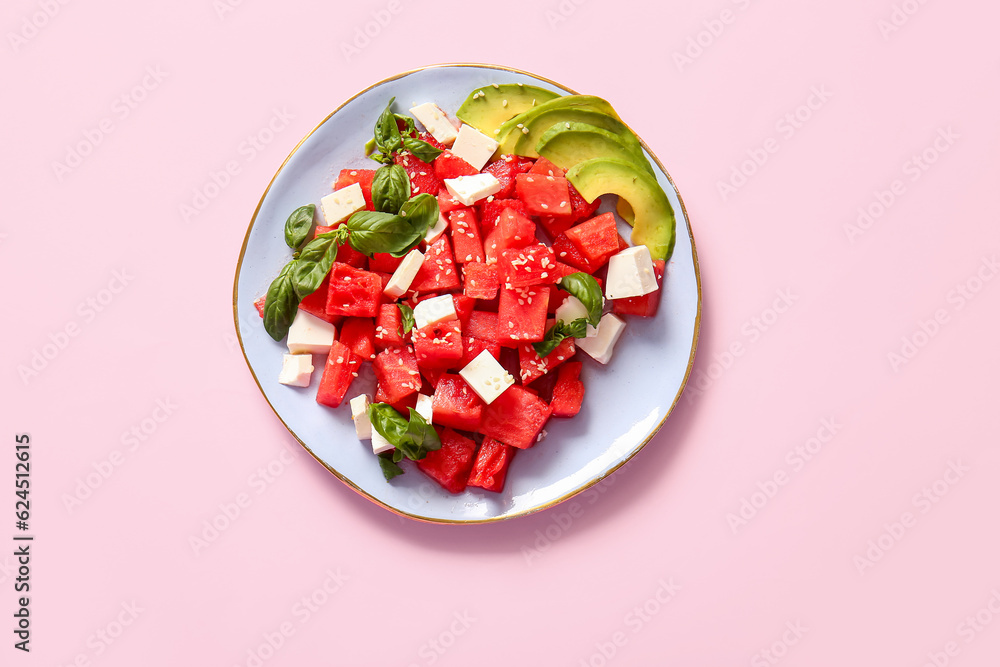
[233,63,702,525]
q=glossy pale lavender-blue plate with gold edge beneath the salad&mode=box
[233,64,701,523]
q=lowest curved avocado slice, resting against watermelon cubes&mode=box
[566,158,676,260]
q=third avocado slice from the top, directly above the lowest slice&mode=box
[535,122,653,176]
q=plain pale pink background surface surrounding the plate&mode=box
[0,0,1000,667]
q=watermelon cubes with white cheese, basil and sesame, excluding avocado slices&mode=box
[255,87,665,493]
